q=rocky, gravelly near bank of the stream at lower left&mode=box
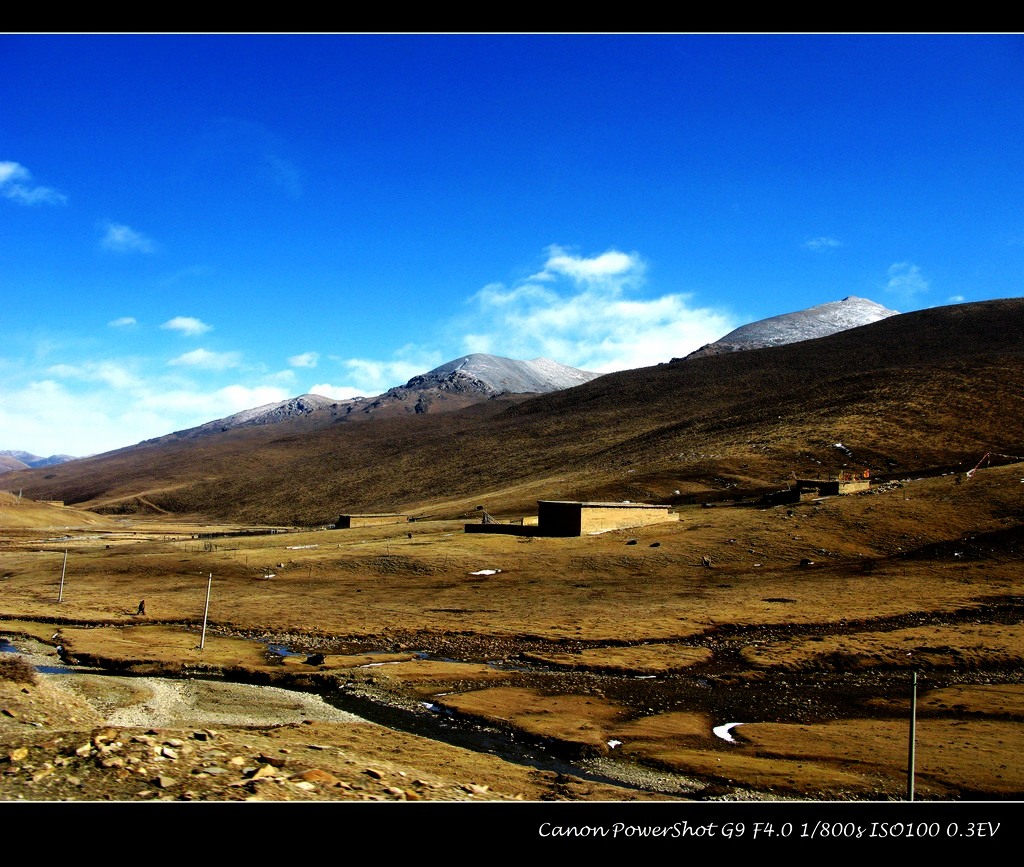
[0,642,700,801]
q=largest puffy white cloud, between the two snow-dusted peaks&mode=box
[463,246,737,373]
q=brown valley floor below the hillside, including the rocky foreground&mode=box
[0,464,1024,801]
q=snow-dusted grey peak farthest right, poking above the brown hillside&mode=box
[673,295,899,361]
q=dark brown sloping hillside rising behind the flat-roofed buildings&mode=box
[5,299,1024,524]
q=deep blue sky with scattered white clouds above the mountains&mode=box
[6,33,1024,456]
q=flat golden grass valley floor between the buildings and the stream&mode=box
[0,465,1024,798]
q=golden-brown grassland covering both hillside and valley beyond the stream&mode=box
[0,299,1024,799]
